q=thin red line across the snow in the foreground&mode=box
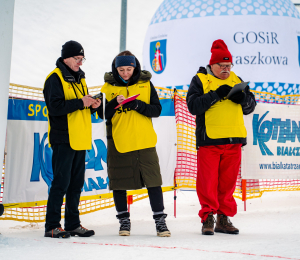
[54,242,300,260]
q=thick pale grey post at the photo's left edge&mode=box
[0,0,15,165]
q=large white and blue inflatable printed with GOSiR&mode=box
[143,0,300,95]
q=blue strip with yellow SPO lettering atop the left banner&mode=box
[7,99,103,123]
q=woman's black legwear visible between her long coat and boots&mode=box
[113,186,165,212]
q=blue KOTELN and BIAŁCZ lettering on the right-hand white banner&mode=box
[252,111,300,156]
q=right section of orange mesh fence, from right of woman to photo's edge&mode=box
[174,90,300,199]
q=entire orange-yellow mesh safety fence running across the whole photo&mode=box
[0,84,300,222]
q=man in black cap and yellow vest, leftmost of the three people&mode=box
[43,41,103,238]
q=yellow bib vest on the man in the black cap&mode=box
[46,68,92,151]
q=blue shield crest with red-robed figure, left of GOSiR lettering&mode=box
[150,39,167,74]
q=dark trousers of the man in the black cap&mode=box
[45,144,85,231]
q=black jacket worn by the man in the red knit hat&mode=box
[186,67,256,147]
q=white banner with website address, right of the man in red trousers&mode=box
[241,103,300,179]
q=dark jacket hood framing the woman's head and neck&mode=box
[104,58,152,86]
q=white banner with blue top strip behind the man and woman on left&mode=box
[3,100,176,207]
